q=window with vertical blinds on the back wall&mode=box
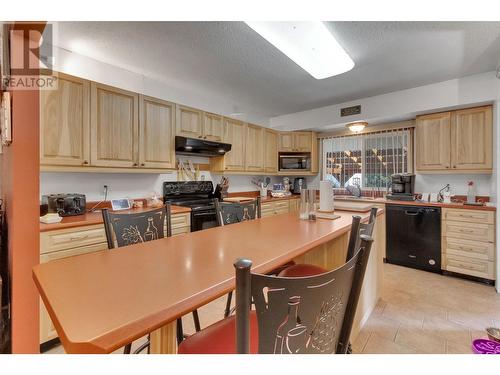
[323,128,412,189]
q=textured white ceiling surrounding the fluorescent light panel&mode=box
[53,22,500,117]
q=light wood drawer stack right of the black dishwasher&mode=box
[441,208,495,280]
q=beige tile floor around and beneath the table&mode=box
[47,264,500,354]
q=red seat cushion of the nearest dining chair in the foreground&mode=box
[177,310,259,354]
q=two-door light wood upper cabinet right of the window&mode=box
[415,106,493,173]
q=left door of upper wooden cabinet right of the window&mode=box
[415,112,451,171]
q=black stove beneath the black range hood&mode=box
[163,181,217,232]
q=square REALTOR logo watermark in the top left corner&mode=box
[0,22,58,90]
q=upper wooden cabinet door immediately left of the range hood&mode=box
[139,96,175,168]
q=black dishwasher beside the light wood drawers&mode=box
[386,204,441,273]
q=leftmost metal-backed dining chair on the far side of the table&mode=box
[102,203,201,354]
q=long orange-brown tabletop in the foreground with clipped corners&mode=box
[33,210,383,353]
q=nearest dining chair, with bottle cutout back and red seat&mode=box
[178,235,373,354]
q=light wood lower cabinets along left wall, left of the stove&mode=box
[40,212,191,344]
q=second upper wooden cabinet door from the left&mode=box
[90,82,139,167]
